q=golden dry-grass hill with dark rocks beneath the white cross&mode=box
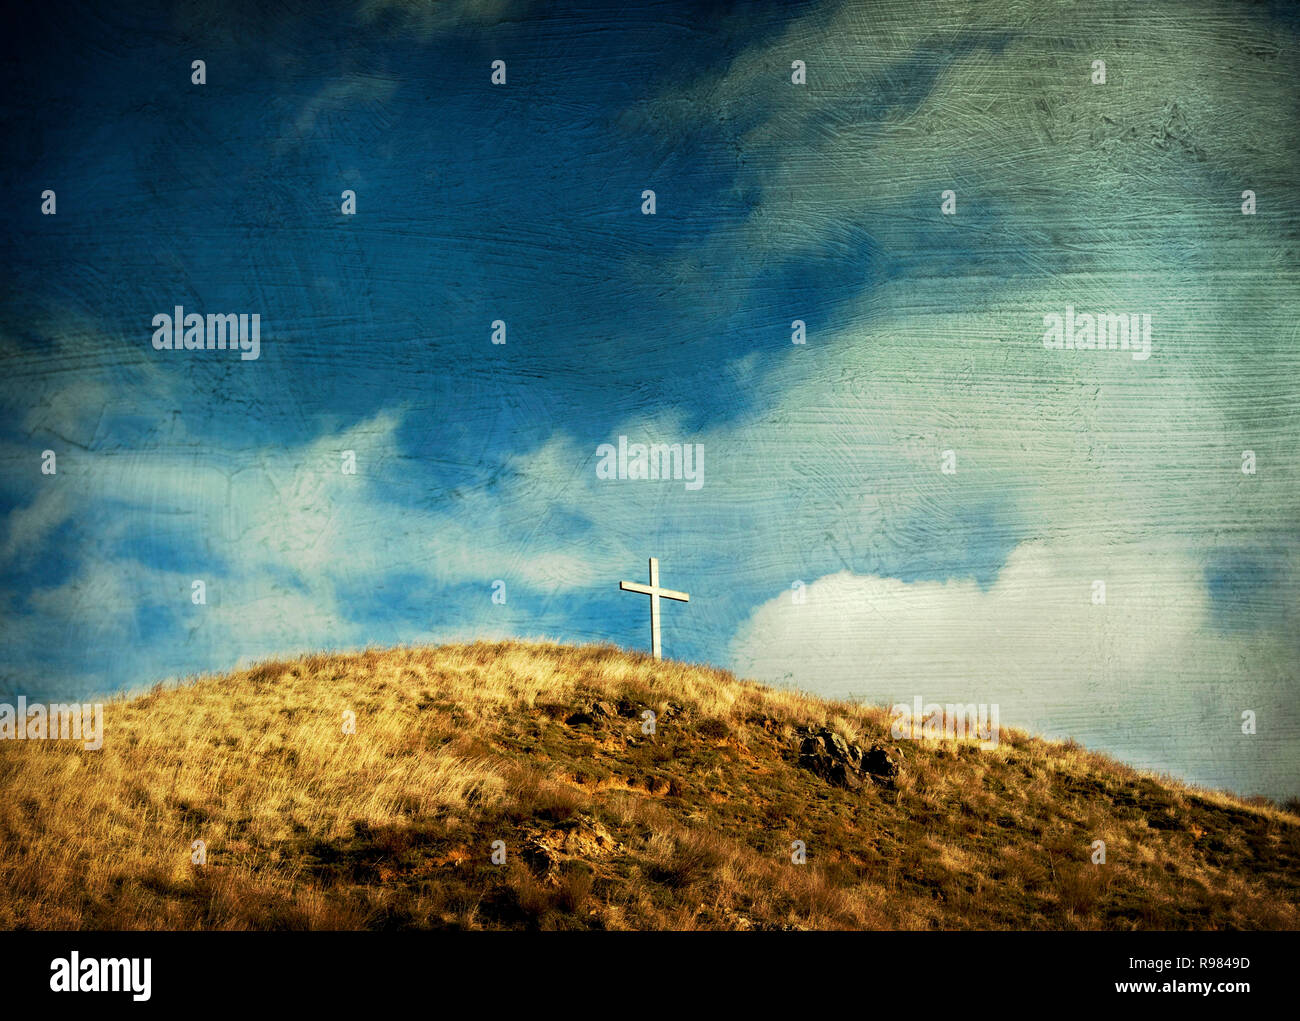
[0,643,1300,929]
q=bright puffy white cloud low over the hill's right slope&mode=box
[732,537,1300,792]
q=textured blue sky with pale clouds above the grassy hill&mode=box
[0,0,1300,797]
